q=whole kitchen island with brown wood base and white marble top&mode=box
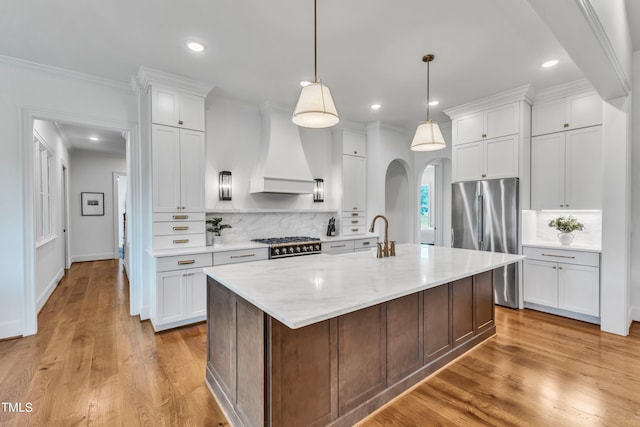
[205,244,523,426]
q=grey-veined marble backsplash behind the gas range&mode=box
[207,212,337,242]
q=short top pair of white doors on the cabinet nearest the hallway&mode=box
[151,86,205,131]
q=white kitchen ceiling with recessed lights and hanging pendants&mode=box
[0,0,640,137]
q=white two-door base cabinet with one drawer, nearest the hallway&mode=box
[151,253,213,331]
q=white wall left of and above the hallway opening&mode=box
[0,57,137,338]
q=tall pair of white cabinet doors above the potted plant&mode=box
[531,126,602,210]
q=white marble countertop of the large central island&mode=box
[204,244,524,329]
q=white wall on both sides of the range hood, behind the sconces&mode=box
[205,95,336,210]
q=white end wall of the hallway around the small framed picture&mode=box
[69,151,127,262]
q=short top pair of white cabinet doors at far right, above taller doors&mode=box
[531,91,602,136]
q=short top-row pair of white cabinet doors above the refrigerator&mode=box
[453,103,520,144]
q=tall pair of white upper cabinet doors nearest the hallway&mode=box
[151,125,205,212]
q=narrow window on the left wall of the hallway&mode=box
[33,131,53,243]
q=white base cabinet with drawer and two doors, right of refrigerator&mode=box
[523,246,600,323]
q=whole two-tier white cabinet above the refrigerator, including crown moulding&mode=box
[446,86,531,182]
